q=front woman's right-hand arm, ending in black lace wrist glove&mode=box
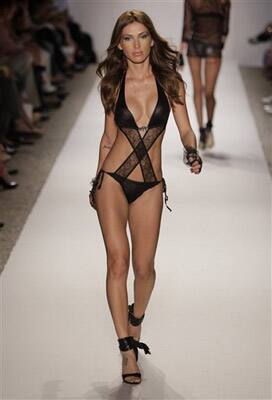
[172,81,202,174]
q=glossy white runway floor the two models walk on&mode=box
[0,63,271,400]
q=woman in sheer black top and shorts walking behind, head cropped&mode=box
[181,0,230,149]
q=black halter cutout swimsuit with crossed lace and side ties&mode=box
[95,76,171,211]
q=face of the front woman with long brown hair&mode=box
[118,21,153,64]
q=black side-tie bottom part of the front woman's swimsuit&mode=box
[95,170,172,211]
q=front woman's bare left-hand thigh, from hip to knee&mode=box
[95,173,129,259]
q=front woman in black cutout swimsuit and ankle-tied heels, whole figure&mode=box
[90,10,202,384]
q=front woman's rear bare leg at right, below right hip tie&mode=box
[129,184,163,339]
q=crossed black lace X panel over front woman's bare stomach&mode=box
[115,127,164,182]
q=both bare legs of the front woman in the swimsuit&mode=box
[95,174,163,382]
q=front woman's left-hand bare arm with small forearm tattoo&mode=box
[96,112,117,175]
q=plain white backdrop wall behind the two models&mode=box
[69,0,272,66]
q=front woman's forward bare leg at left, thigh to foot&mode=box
[95,174,140,382]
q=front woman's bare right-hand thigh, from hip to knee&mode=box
[128,183,163,268]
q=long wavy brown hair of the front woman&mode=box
[96,10,183,113]
